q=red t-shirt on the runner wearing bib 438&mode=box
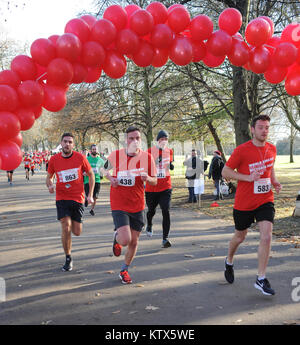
[108,149,156,213]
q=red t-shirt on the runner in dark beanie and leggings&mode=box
[146,146,173,192]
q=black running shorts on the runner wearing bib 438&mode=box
[111,210,145,232]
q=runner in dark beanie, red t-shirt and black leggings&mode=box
[145,130,174,248]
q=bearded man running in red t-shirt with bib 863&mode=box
[46,133,95,271]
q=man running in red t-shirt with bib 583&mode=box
[222,115,281,295]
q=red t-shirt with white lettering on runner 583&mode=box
[226,140,276,211]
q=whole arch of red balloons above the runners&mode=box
[0,2,300,170]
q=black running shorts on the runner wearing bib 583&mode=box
[233,202,275,231]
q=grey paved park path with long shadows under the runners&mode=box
[0,168,300,325]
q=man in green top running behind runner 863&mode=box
[83,144,104,216]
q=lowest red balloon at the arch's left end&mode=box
[0,140,23,171]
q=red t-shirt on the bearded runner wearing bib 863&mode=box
[48,151,92,203]
